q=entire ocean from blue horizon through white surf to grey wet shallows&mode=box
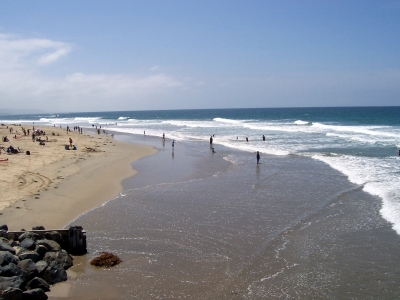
[0,107,400,299]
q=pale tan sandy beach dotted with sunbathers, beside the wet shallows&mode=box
[0,124,157,230]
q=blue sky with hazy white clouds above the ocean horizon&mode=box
[0,0,400,113]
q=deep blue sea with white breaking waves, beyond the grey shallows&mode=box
[0,107,400,234]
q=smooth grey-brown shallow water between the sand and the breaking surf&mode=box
[55,135,400,299]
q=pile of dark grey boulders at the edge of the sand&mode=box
[0,225,73,300]
